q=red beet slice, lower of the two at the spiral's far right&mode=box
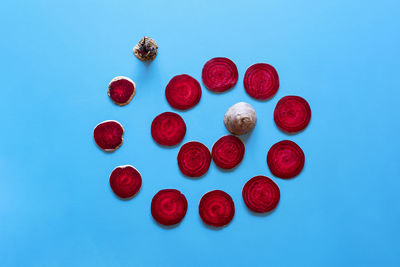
[267,140,305,179]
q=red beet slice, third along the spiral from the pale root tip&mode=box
[151,112,186,146]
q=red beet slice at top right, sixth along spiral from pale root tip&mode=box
[244,63,279,100]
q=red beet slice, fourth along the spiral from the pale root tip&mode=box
[165,74,201,110]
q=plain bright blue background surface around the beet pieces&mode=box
[0,0,400,266]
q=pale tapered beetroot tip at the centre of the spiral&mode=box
[224,102,257,135]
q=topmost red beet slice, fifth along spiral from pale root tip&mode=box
[201,57,239,92]
